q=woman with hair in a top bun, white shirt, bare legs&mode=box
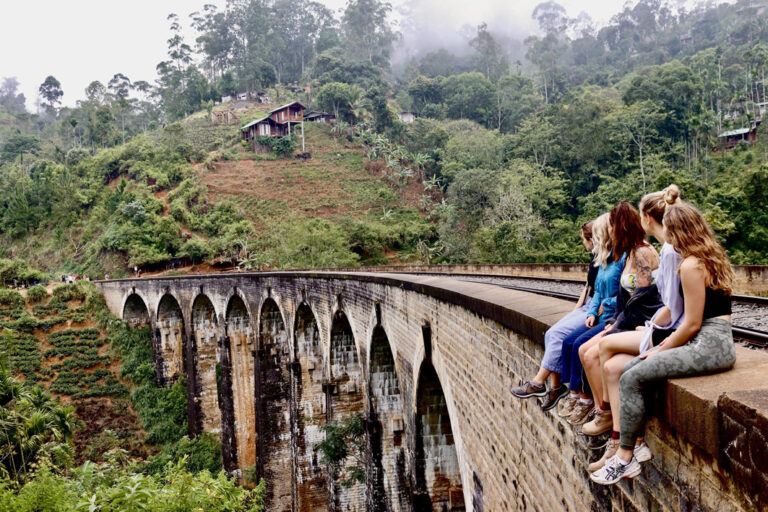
[580,185,683,472]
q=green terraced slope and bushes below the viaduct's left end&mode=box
[0,281,263,511]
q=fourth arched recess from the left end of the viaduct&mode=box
[222,294,256,469]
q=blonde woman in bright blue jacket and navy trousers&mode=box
[558,210,626,424]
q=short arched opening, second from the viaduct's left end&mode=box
[155,294,185,386]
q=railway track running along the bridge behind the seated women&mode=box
[388,272,768,349]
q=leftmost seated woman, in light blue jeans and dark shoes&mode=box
[512,221,600,411]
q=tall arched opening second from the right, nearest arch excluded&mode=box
[366,326,411,512]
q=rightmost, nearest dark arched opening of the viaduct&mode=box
[413,362,464,512]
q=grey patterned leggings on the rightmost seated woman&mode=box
[619,318,736,450]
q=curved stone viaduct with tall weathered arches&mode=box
[97,272,768,512]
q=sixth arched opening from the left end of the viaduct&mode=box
[294,303,328,512]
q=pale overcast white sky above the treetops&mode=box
[0,0,623,109]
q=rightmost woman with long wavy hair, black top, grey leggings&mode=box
[590,196,736,485]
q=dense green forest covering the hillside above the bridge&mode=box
[0,0,768,275]
